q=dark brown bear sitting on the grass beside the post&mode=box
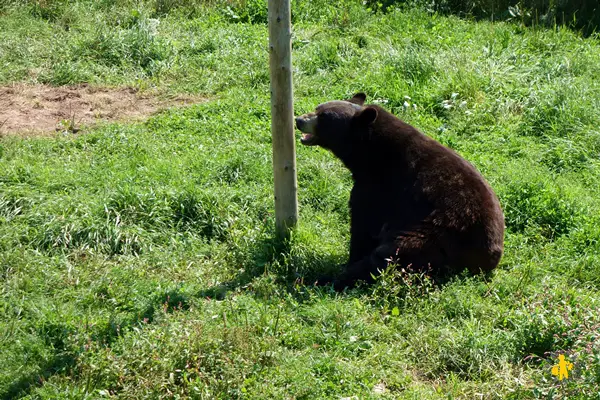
[296,93,504,290]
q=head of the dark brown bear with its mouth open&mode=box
[296,93,377,161]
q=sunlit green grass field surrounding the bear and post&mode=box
[0,0,600,399]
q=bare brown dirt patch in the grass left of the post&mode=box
[0,84,205,135]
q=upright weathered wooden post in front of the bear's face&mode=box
[268,0,298,238]
